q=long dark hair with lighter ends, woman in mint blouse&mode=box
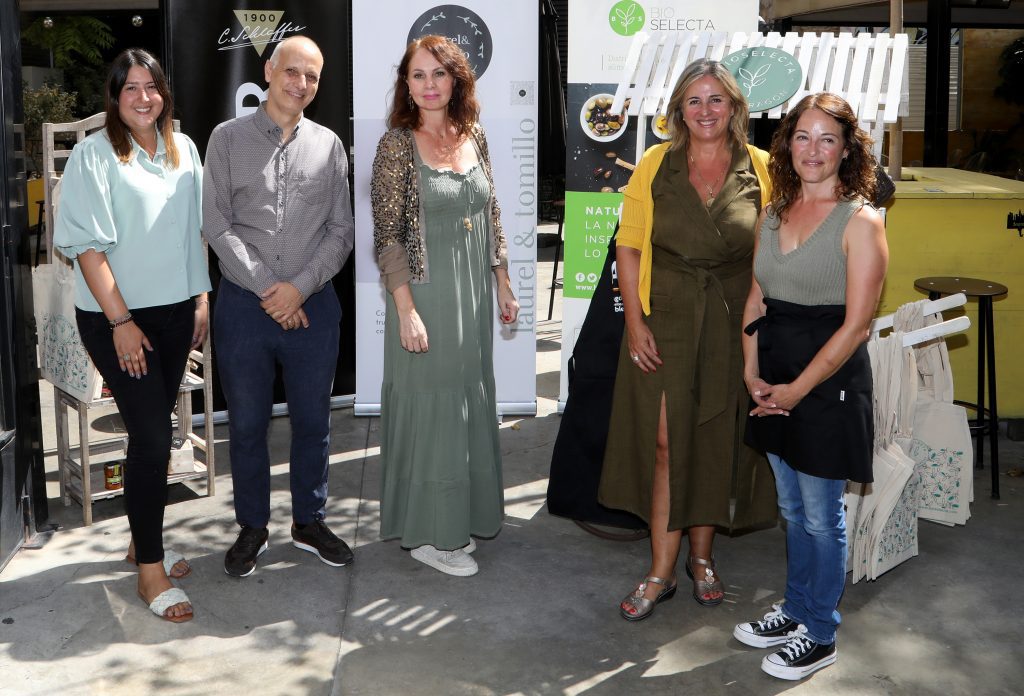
[106,48,178,169]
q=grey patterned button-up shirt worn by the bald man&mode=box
[203,102,354,298]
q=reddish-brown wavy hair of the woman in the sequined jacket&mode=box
[387,34,480,135]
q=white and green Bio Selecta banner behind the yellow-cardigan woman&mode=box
[558,0,758,410]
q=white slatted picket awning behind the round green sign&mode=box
[611,32,908,128]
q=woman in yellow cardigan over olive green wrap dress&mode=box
[598,60,776,621]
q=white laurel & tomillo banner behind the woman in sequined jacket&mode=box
[352,0,539,416]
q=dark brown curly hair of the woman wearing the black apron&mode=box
[768,92,876,220]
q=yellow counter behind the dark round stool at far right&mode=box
[879,169,1024,418]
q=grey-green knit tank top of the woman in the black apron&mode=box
[754,199,864,305]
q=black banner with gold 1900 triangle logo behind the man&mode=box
[162,0,355,409]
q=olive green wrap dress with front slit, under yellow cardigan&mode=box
[598,142,777,533]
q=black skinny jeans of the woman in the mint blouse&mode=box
[76,299,196,563]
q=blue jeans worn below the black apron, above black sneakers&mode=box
[768,452,846,645]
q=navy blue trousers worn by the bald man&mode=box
[213,278,341,529]
